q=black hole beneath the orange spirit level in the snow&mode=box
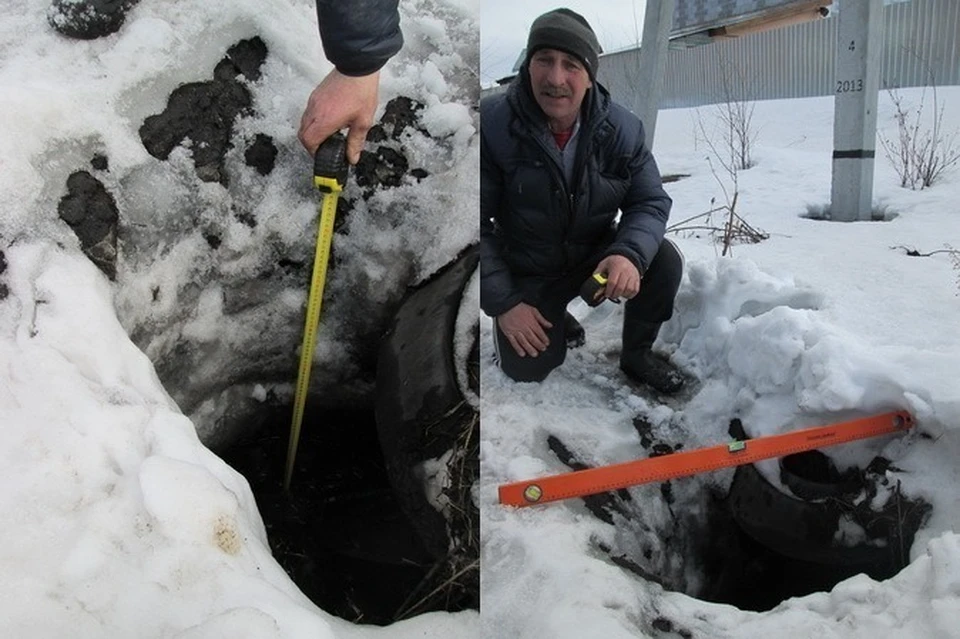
[699,451,930,611]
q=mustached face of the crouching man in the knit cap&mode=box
[530,49,593,131]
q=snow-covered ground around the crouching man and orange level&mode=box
[480,87,960,639]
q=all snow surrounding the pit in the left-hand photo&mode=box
[0,0,479,639]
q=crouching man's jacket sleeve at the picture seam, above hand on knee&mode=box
[480,101,523,317]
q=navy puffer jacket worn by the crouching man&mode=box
[480,68,672,316]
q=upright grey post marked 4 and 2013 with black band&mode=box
[830,0,883,222]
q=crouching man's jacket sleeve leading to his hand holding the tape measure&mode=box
[606,110,673,275]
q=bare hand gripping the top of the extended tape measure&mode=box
[297,69,380,164]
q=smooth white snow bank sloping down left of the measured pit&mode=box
[0,243,476,639]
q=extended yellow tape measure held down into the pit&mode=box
[283,133,348,490]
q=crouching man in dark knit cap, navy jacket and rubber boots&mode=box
[480,9,683,393]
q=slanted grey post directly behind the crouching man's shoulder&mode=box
[633,0,676,142]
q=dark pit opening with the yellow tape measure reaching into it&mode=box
[205,246,480,625]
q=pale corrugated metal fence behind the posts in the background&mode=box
[598,0,960,108]
